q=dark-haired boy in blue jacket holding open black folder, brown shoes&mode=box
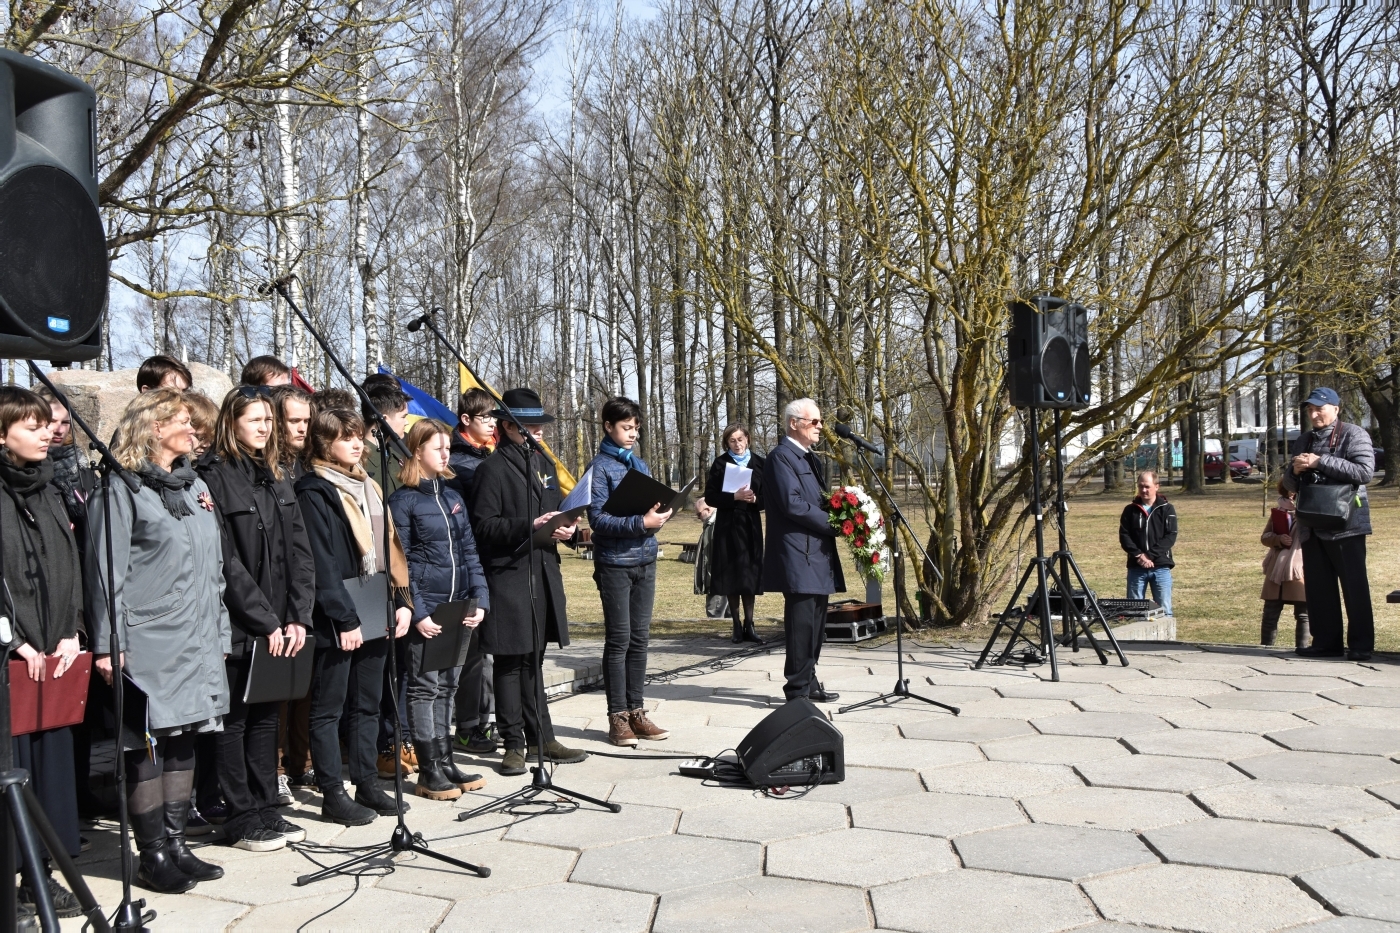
[588,398,671,747]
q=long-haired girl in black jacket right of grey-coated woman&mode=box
[197,385,316,852]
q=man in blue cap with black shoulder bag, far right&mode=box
[1282,388,1376,661]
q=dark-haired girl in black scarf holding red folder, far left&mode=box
[0,385,83,918]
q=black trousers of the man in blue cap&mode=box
[1303,535,1376,651]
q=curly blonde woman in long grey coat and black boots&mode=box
[85,388,231,894]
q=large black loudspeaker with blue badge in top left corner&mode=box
[0,50,106,363]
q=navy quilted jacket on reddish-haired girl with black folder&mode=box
[389,479,491,622]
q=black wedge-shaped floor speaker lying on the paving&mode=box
[735,698,846,787]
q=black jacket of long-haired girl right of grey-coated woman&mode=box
[196,451,316,657]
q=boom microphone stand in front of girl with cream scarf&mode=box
[264,276,491,887]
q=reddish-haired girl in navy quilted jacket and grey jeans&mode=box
[389,417,490,800]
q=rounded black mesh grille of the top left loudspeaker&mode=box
[0,165,106,346]
